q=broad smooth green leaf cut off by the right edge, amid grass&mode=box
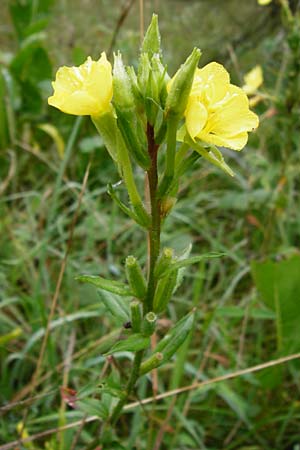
[251,255,300,354]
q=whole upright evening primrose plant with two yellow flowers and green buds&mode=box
[49,15,258,436]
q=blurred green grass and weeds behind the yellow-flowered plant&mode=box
[0,0,300,450]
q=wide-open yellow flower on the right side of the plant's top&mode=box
[185,62,258,150]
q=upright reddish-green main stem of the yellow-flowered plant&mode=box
[110,123,161,424]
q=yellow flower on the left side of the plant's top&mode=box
[48,52,113,116]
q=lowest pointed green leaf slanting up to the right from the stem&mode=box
[140,310,195,375]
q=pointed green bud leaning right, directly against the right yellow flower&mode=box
[166,48,201,118]
